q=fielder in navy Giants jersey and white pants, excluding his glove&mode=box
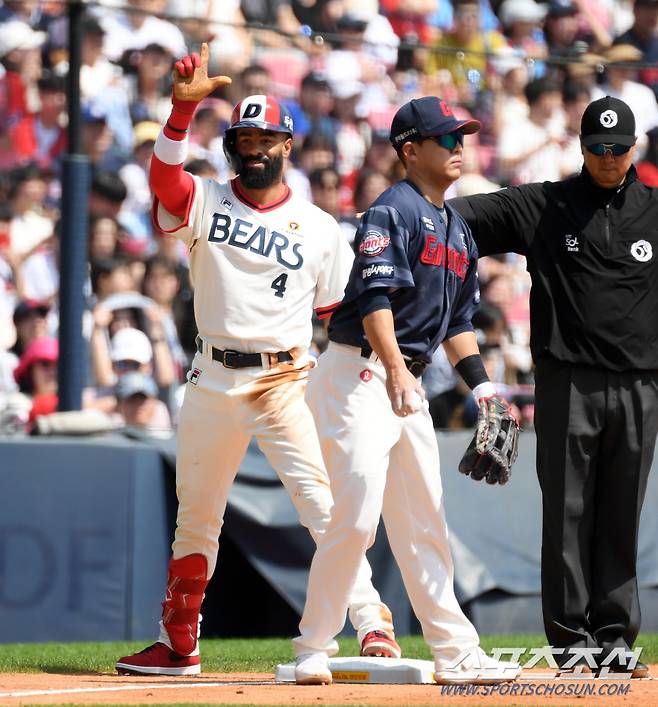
[293,97,520,684]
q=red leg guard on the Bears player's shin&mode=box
[162,554,208,655]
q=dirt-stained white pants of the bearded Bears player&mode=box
[172,354,393,640]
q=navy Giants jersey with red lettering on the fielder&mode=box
[329,180,479,363]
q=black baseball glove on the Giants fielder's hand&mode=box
[459,395,519,486]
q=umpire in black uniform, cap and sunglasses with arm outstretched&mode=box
[450,96,658,677]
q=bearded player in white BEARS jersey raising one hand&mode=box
[116,44,400,675]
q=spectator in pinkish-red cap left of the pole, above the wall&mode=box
[14,337,59,419]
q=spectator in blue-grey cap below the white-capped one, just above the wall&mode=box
[114,373,172,436]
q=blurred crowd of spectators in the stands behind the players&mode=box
[0,0,658,431]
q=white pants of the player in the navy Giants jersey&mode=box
[293,343,479,663]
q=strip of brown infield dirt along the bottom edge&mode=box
[0,665,658,707]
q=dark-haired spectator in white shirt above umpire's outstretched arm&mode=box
[498,78,564,184]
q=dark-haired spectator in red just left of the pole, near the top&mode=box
[13,72,66,171]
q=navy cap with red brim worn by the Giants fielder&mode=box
[389,96,480,150]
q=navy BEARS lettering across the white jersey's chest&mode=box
[208,213,304,270]
